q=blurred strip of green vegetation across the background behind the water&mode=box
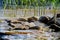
[2,0,60,9]
